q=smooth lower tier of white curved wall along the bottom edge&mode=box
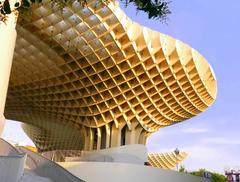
[59,162,207,182]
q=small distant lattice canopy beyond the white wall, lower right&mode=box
[148,152,188,169]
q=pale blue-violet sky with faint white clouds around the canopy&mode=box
[3,0,240,173]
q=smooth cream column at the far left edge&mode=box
[0,22,17,135]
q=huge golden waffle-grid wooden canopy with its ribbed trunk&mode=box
[5,0,216,151]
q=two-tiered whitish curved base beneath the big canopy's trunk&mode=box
[59,145,206,182]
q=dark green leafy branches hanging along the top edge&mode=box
[0,0,171,21]
